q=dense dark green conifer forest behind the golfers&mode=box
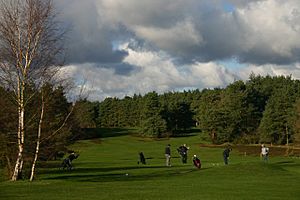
[71,74,300,144]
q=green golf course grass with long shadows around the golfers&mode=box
[0,130,300,200]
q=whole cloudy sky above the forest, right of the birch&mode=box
[54,0,300,101]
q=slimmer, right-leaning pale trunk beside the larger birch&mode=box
[29,92,45,181]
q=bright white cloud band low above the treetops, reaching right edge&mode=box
[63,41,300,101]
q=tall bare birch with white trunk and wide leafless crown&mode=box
[0,0,64,181]
